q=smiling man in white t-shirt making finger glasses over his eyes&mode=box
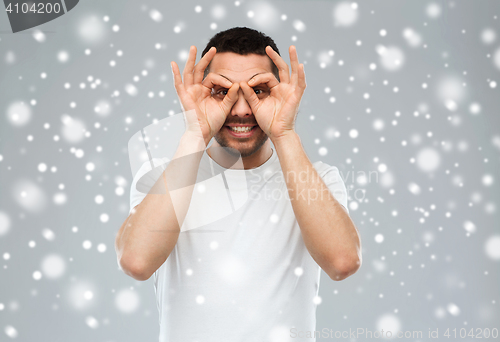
[116,27,361,342]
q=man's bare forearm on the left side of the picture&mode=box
[115,134,205,280]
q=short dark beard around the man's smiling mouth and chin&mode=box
[214,126,269,158]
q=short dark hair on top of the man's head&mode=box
[201,27,281,81]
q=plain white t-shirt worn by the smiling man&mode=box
[130,150,347,342]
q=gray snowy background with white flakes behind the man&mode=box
[0,0,500,342]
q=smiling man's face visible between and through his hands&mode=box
[210,52,272,157]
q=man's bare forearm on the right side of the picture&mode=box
[273,133,361,280]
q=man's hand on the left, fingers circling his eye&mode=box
[170,45,239,146]
